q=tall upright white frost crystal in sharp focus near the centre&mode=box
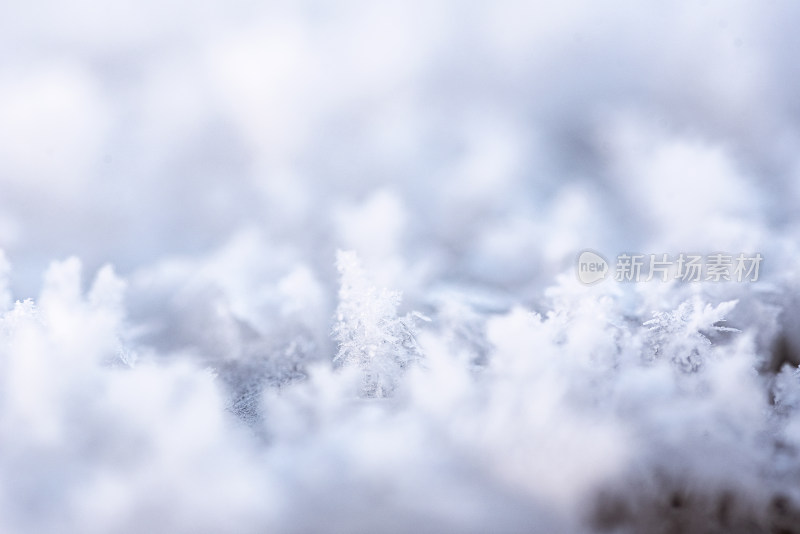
[333,251,422,397]
